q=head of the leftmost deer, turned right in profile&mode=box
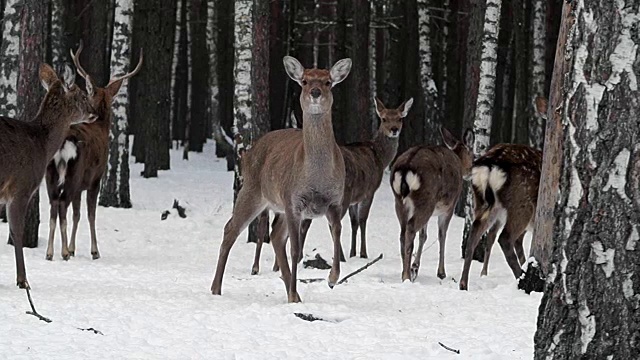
[40,64,98,124]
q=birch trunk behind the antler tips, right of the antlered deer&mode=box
[100,0,133,208]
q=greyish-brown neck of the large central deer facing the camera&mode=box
[302,113,337,174]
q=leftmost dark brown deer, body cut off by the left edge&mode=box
[0,64,96,289]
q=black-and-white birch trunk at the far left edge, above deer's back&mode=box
[0,0,20,118]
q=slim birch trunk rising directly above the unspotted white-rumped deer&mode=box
[418,0,440,144]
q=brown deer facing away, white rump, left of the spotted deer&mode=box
[390,127,474,281]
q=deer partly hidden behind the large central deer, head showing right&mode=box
[251,97,413,274]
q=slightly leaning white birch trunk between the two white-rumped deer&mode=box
[463,0,502,258]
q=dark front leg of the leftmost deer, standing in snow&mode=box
[7,196,30,289]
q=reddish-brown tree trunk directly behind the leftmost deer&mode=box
[10,0,49,248]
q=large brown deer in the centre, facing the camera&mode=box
[211,56,351,302]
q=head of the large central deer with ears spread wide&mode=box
[283,56,351,115]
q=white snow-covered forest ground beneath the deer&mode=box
[0,142,540,359]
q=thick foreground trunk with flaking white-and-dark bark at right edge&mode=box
[534,0,640,360]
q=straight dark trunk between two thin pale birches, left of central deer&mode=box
[189,0,209,152]
